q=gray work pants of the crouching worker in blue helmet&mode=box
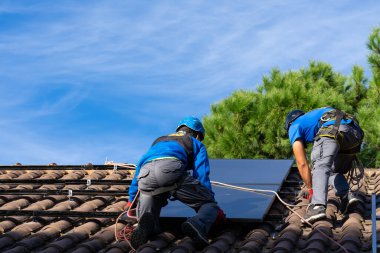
[137,159,219,234]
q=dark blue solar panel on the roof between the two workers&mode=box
[161,159,293,221]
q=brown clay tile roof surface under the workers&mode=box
[0,165,380,253]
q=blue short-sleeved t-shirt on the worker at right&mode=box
[288,107,352,146]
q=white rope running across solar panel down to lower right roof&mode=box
[211,181,349,253]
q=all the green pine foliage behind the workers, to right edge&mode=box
[204,26,380,167]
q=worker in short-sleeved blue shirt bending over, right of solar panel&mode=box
[285,107,364,222]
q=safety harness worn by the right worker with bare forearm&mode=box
[315,109,360,154]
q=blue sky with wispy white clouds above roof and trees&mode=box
[0,0,380,165]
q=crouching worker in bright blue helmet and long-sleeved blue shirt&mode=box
[129,117,224,249]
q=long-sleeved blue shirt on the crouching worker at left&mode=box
[129,134,214,202]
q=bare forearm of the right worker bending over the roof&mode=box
[293,140,312,189]
